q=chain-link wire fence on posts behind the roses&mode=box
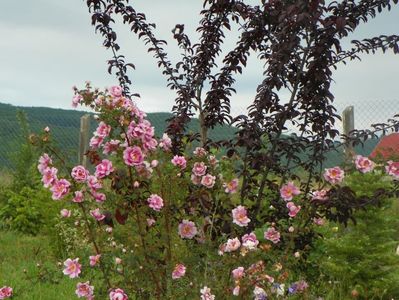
[0,100,399,169]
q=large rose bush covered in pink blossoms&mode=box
[28,83,396,299]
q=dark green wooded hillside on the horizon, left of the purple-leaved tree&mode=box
[0,103,235,169]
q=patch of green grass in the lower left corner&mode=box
[0,232,79,300]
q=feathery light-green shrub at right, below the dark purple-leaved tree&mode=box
[311,173,399,299]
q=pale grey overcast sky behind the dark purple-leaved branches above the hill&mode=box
[0,0,399,128]
